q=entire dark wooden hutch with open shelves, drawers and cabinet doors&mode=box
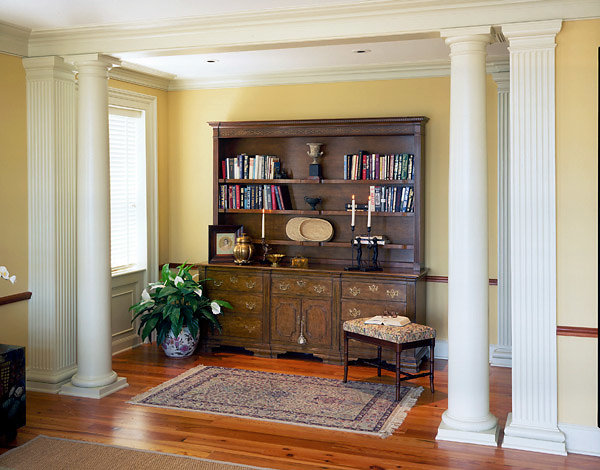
[200,117,428,371]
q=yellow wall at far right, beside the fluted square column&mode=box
[556,20,600,426]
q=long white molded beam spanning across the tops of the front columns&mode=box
[29,0,600,56]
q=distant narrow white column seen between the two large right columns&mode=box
[490,64,512,367]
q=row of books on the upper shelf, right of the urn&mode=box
[344,150,415,180]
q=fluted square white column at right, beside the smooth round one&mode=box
[502,20,566,455]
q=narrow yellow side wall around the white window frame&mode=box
[108,80,170,263]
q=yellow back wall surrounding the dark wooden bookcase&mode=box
[169,77,497,343]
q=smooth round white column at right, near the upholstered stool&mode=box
[436,26,498,446]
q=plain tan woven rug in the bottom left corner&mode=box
[0,436,272,470]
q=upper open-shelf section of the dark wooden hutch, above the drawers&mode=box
[209,117,428,271]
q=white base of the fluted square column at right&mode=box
[502,413,567,455]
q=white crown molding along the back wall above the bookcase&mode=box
[169,58,508,91]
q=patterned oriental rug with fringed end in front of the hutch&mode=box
[129,366,423,437]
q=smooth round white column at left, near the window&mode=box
[60,54,127,398]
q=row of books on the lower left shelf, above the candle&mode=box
[219,184,292,210]
